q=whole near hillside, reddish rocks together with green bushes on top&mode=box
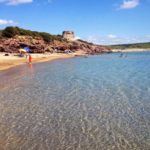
[0,27,111,54]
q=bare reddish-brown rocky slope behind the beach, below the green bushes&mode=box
[0,36,111,54]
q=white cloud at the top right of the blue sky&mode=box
[119,0,140,9]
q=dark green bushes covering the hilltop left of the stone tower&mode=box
[0,27,65,43]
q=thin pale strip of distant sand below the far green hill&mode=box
[112,48,150,52]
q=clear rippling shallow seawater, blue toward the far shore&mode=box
[0,52,150,150]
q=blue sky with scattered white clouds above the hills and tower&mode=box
[0,0,150,45]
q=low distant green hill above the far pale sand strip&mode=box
[108,42,150,50]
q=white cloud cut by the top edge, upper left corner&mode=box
[0,0,33,5]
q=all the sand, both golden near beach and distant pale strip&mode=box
[0,48,150,71]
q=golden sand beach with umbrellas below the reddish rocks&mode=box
[0,51,85,71]
